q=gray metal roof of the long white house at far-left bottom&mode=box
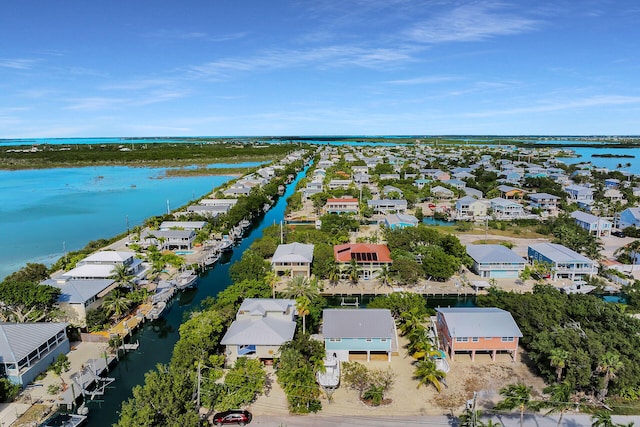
[0,322,67,363]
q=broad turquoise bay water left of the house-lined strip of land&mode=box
[0,163,248,278]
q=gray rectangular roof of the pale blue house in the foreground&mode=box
[322,308,395,338]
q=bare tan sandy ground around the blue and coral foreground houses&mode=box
[249,338,545,416]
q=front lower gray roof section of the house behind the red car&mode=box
[220,317,296,345]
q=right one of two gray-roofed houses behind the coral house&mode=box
[467,245,527,279]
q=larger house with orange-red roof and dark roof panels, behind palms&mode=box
[333,243,393,280]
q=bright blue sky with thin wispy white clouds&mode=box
[0,0,640,138]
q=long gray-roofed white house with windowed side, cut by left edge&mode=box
[0,322,69,387]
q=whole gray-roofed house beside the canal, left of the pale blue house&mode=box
[220,298,297,366]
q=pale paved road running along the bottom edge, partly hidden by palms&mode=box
[250,410,640,427]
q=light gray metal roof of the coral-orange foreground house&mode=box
[436,307,522,338]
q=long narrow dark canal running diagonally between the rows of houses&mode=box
[88,163,307,427]
